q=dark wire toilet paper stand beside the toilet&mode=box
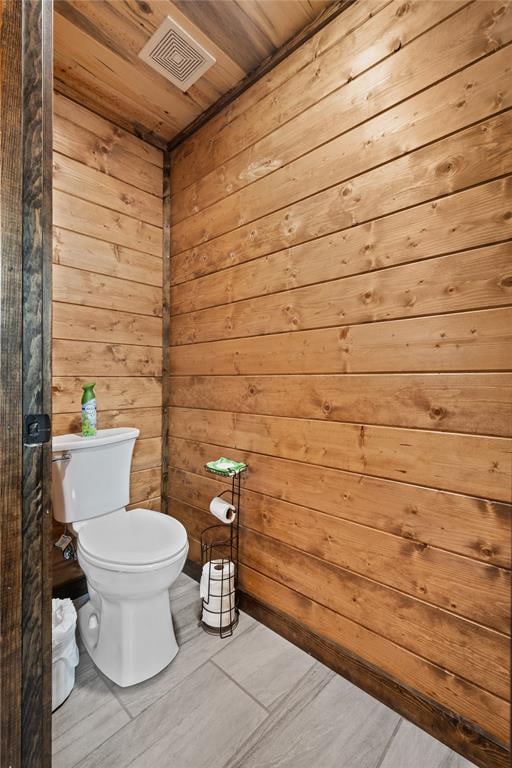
[201,465,246,638]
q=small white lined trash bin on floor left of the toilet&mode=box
[52,598,78,712]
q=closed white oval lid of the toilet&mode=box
[79,509,187,565]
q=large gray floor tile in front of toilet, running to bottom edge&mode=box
[80,662,267,768]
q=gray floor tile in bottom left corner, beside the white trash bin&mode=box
[52,662,130,768]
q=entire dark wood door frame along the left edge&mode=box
[0,0,53,768]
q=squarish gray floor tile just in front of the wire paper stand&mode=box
[213,623,315,708]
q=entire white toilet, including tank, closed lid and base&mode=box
[52,428,188,686]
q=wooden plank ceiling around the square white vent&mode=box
[54,0,333,146]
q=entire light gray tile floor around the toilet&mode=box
[52,574,472,768]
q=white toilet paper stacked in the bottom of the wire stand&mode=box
[199,560,235,629]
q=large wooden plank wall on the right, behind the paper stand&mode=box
[169,0,512,744]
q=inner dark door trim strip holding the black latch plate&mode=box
[21,0,53,768]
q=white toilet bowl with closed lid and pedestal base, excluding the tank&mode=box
[77,509,188,686]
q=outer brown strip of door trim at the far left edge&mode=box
[0,0,22,767]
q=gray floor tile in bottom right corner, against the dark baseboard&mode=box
[380,720,474,768]
